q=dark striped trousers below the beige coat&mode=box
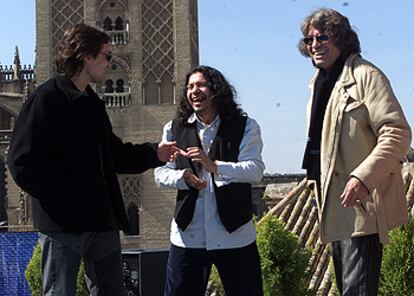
[332,234,382,296]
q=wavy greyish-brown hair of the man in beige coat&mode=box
[298,8,361,57]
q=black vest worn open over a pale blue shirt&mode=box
[172,115,252,232]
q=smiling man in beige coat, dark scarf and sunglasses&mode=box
[299,8,411,296]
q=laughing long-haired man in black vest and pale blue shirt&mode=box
[155,66,265,296]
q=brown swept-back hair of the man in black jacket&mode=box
[55,23,110,77]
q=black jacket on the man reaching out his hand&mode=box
[7,75,162,232]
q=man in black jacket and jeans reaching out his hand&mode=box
[7,24,177,296]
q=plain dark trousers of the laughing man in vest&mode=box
[164,242,263,296]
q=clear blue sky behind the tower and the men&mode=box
[0,0,414,173]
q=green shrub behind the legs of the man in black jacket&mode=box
[25,243,89,296]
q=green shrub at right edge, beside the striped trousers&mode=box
[379,217,414,296]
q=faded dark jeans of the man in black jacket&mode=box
[39,233,126,296]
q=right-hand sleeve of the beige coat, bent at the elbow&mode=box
[351,70,411,191]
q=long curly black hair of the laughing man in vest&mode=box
[176,66,244,123]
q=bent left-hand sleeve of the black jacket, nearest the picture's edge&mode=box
[7,96,80,204]
